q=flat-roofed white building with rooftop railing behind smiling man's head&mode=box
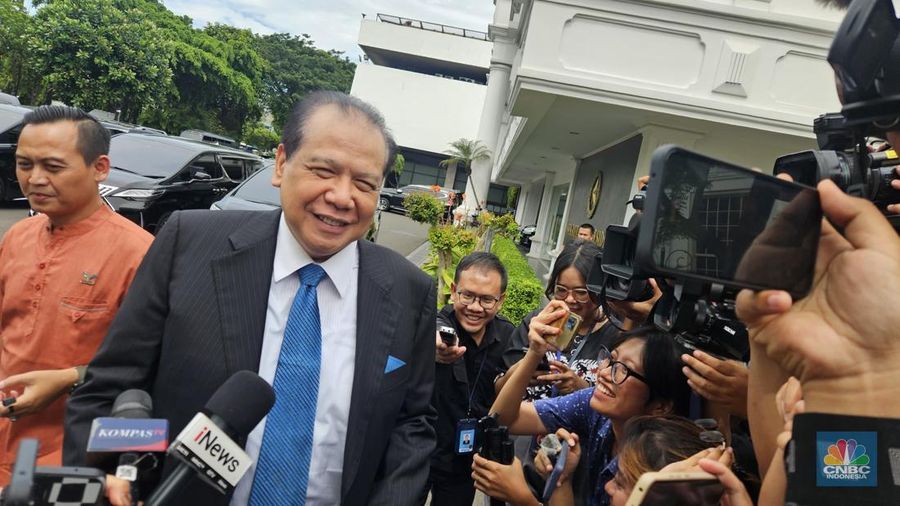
[350,14,506,211]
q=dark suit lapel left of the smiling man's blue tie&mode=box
[212,211,281,377]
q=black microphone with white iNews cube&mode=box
[147,371,275,506]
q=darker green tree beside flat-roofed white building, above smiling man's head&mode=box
[256,33,356,130]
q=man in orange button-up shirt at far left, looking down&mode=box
[0,106,153,484]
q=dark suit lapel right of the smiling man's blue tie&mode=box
[341,241,403,496]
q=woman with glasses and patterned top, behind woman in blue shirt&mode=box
[496,239,619,400]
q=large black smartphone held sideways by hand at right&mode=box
[635,145,822,298]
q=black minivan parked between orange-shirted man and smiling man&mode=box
[100,133,263,232]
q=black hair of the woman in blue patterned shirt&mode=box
[617,326,691,416]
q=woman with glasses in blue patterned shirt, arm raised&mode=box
[478,301,690,505]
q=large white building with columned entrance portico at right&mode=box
[473,0,856,272]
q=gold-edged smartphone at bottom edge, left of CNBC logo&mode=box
[626,473,725,506]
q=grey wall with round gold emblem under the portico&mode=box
[566,135,642,244]
